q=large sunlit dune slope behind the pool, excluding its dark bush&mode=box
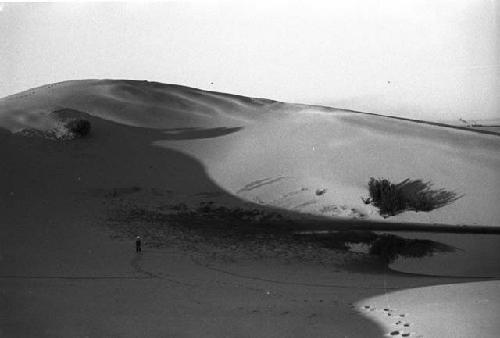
[0,80,500,225]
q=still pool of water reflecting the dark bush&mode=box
[294,231,500,278]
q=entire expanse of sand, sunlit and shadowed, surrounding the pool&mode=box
[0,80,500,337]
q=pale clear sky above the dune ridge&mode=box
[0,0,500,120]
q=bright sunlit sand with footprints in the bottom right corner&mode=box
[358,281,500,338]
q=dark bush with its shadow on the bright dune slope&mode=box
[365,177,462,217]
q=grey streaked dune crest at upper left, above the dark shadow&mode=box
[1,80,274,130]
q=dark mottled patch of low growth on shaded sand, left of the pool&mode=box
[107,202,342,265]
